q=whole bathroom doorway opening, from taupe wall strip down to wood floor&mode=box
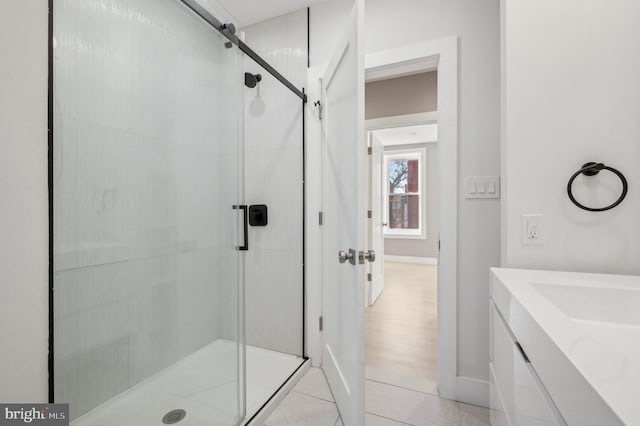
[364,64,440,391]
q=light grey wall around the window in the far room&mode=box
[384,143,439,258]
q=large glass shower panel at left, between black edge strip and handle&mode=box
[53,0,244,426]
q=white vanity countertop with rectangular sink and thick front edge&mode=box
[491,268,640,426]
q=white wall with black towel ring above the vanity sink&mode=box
[502,0,640,274]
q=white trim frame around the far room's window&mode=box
[382,144,427,240]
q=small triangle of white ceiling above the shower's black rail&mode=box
[218,0,336,28]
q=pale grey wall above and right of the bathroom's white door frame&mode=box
[310,0,500,388]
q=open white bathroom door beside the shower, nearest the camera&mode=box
[322,0,368,426]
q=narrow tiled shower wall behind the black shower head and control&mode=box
[243,9,308,355]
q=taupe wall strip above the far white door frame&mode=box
[364,71,438,120]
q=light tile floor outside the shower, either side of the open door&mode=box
[264,368,489,426]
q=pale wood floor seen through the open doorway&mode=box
[365,262,438,381]
